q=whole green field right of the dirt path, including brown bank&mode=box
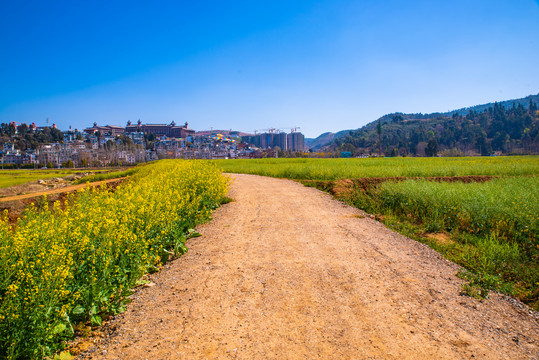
[211,156,539,309]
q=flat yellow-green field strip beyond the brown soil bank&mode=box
[214,156,539,180]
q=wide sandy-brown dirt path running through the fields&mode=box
[83,175,539,360]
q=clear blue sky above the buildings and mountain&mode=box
[0,0,539,137]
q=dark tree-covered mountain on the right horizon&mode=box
[330,94,539,156]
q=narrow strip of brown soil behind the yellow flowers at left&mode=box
[0,178,124,221]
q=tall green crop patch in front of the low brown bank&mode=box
[377,176,539,245]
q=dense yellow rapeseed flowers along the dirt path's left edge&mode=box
[0,160,228,359]
